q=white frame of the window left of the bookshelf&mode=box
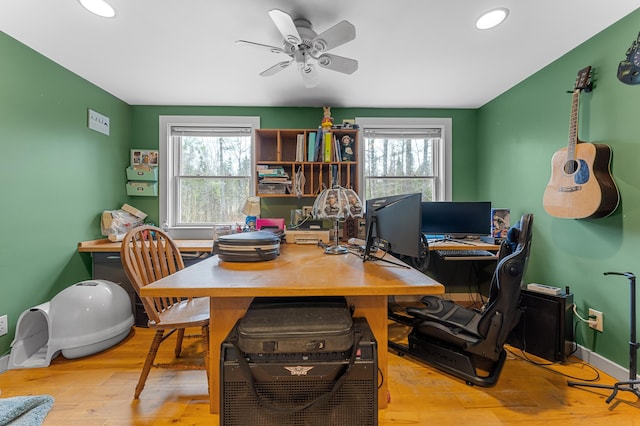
[158,115,260,239]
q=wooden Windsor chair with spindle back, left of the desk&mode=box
[120,225,210,399]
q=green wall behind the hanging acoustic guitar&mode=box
[478,11,640,367]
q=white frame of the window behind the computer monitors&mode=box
[355,117,453,201]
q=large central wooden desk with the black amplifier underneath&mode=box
[141,244,444,413]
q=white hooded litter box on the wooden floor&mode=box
[9,280,133,369]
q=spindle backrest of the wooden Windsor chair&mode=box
[120,225,184,323]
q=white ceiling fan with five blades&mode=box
[236,9,358,87]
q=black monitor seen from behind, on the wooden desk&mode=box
[363,193,422,261]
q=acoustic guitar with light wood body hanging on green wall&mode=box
[542,66,620,219]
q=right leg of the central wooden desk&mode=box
[347,296,389,409]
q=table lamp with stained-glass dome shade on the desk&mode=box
[311,186,362,254]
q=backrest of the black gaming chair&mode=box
[478,214,533,346]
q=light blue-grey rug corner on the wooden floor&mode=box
[0,395,53,426]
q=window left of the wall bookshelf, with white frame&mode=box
[160,116,260,238]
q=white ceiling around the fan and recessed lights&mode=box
[0,0,640,108]
